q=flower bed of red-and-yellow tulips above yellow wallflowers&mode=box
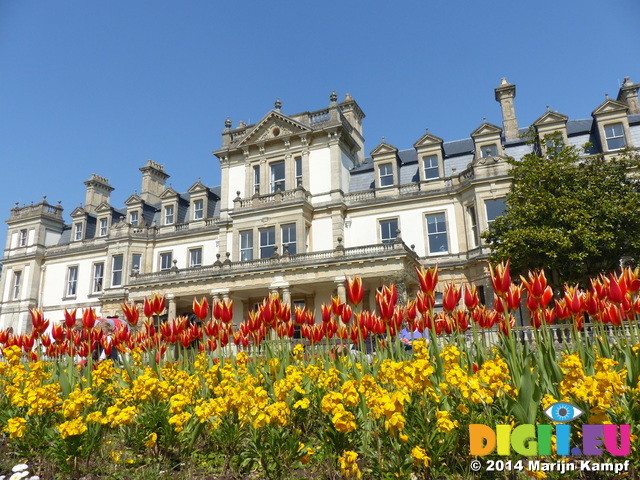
[0,264,640,479]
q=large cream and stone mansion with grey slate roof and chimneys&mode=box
[0,79,640,332]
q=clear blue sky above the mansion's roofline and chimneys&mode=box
[0,0,640,251]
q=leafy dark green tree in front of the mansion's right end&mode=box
[483,135,640,288]
